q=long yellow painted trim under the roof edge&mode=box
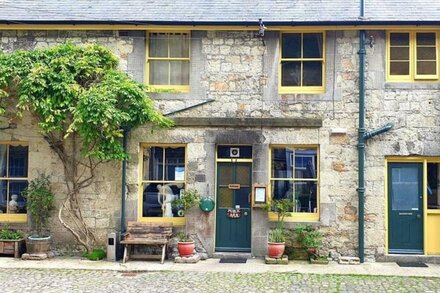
[0,24,438,32]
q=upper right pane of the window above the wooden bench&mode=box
[165,147,185,181]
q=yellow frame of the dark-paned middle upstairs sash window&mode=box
[278,31,326,94]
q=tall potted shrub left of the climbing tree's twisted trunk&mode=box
[23,174,55,254]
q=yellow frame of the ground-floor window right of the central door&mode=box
[268,144,321,222]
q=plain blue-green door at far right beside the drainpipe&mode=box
[388,163,423,254]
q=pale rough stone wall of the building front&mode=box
[0,29,440,260]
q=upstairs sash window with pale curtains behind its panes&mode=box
[147,32,190,91]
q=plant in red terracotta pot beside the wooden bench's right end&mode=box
[173,190,200,257]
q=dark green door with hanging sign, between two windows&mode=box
[216,163,252,251]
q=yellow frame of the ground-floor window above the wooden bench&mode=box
[138,143,188,226]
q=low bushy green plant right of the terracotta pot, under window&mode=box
[295,225,328,263]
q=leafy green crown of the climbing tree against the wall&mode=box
[0,43,173,160]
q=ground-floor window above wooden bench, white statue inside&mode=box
[141,145,186,220]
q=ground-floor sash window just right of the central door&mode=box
[270,145,319,220]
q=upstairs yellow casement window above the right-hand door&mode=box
[387,32,439,81]
